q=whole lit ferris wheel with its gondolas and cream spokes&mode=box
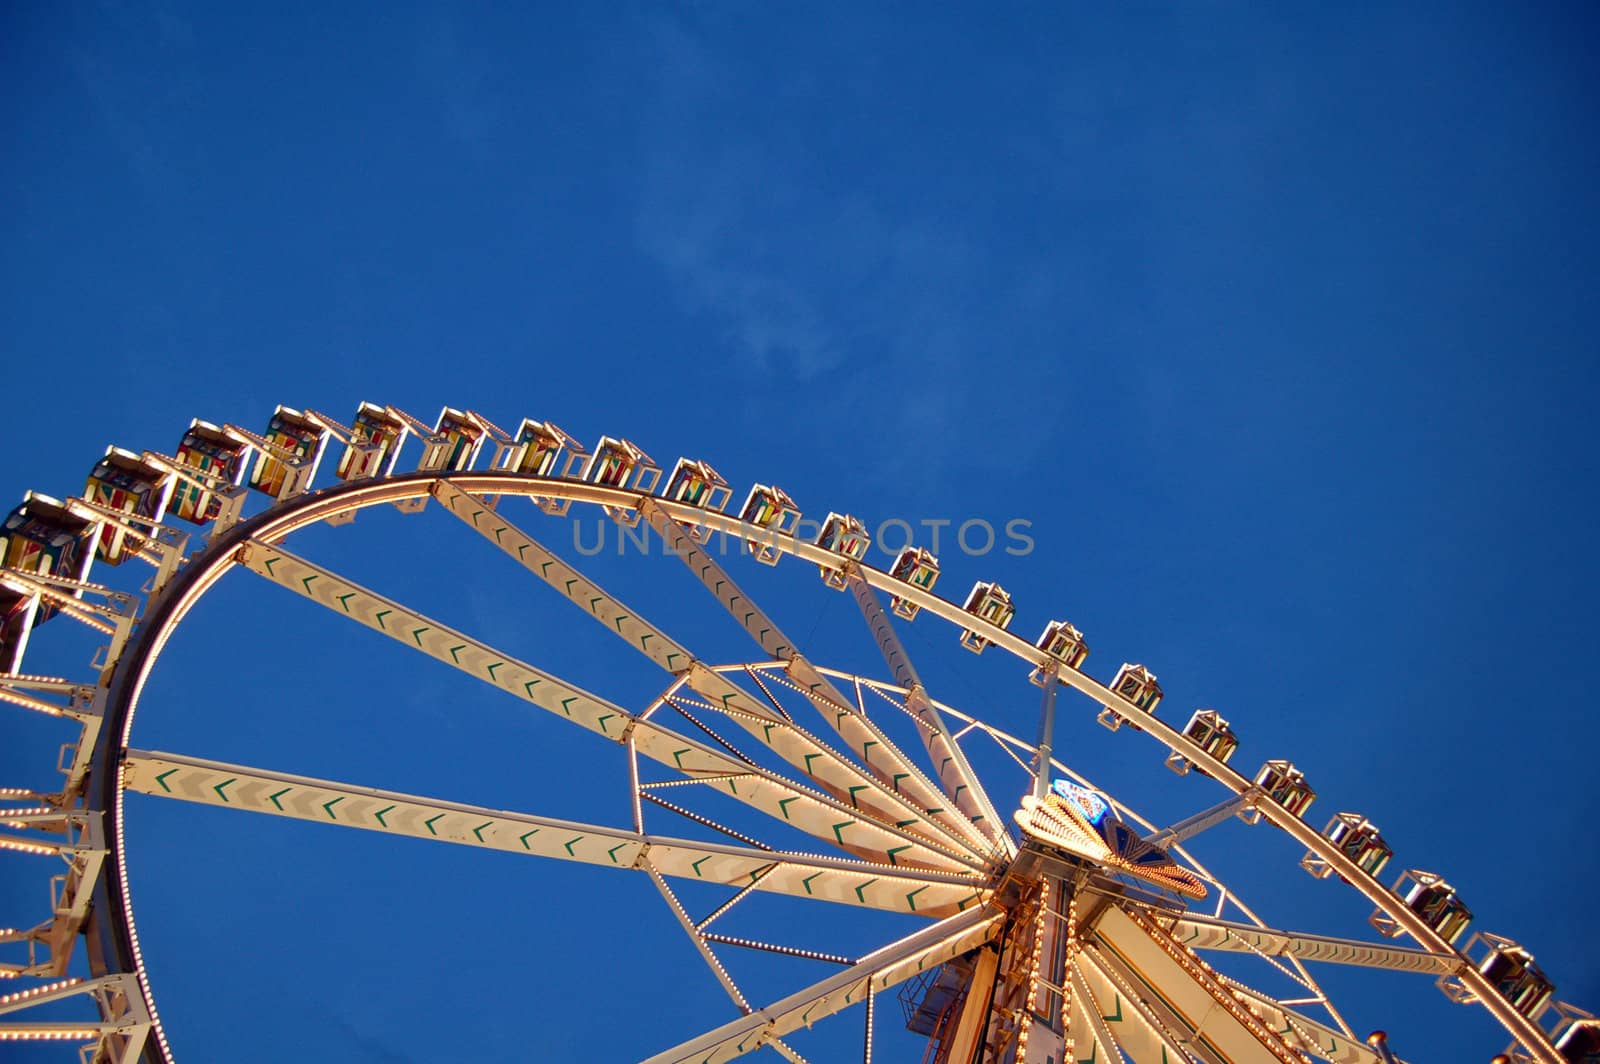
[0,403,1600,1064]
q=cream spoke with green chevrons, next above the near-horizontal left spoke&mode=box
[237,541,979,869]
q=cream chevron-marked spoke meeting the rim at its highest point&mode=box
[435,480,986,861]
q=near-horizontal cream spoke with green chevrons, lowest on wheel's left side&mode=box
[123,750,984,918]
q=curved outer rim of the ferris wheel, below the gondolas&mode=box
[78,472,1563,1064]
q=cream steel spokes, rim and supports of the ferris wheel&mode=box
[0,406,1582,1064]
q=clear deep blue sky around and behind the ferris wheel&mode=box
[0,3,1600,1061]
